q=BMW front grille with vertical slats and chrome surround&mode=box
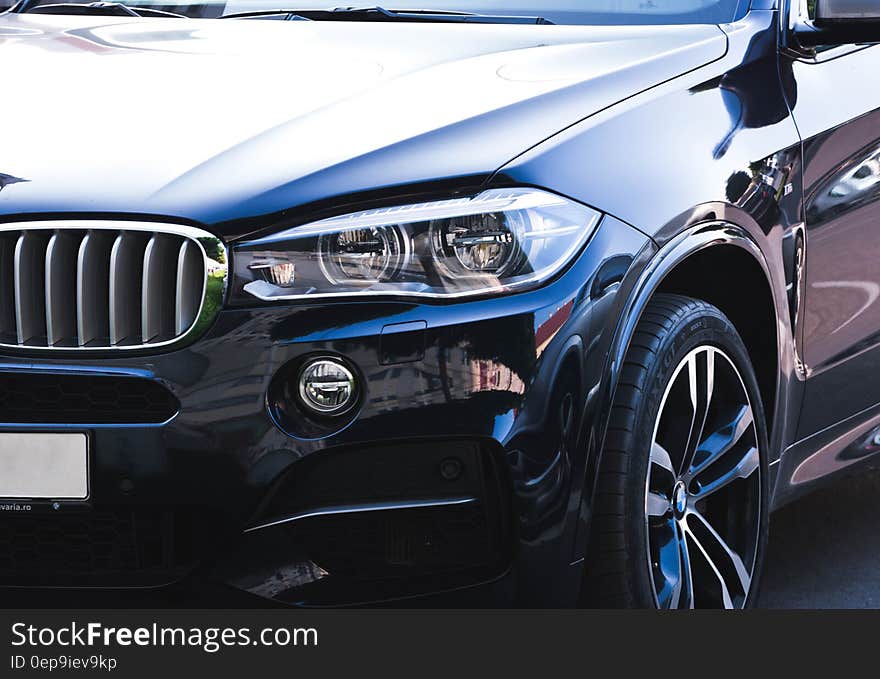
[0,222,226,351]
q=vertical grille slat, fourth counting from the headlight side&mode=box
[76,231,116,347]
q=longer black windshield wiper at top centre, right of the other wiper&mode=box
[220,7,553,24]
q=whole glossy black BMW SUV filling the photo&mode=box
[0,0,880,608]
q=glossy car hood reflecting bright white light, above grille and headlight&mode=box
[0,15,727,237]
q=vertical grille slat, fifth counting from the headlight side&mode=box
[46,231,81,346]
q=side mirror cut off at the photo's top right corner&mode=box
[794,0,880,47]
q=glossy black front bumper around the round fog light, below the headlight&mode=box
[0,219,647,604]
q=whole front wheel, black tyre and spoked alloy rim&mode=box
[584,295,768,608]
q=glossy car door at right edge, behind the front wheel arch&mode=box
[782,7,880,438]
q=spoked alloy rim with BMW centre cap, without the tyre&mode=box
[645,345,763,608]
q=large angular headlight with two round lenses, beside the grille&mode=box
[234,189,600,301]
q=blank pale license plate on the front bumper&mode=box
[0,433,89,500]
